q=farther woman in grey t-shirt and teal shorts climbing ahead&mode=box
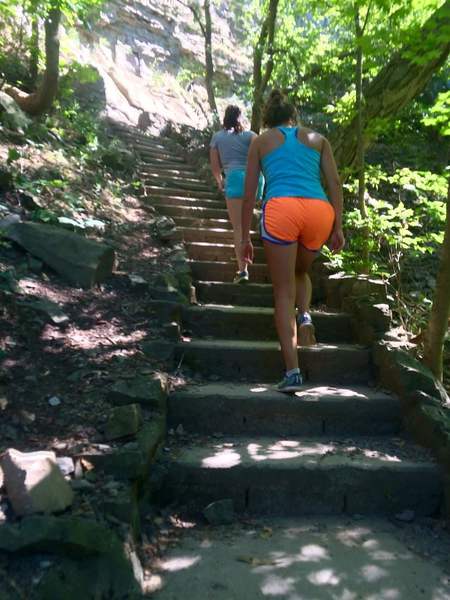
[210,105,263,283]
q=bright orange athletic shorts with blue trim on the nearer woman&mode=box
[261,197,335,251]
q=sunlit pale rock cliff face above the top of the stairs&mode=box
[71,0,251,130]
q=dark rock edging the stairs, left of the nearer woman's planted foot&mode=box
[108,373,168,411]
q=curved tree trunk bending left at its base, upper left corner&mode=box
[5,8,61,116]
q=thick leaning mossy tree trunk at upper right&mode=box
[332,0,450,169]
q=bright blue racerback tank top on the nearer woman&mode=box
[261,127,328,201]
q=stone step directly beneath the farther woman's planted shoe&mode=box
[195,281,273,307]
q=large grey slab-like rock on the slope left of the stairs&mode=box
[6,223,114,287]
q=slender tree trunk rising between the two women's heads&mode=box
[251,0,279,133]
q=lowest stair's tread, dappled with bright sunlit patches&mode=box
[169,435,439,474]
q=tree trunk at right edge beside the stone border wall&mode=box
[423,184,450,381]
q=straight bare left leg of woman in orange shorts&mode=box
[264,242,298,371]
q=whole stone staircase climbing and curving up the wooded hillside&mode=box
[110,122,442,516]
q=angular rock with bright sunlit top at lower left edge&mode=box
[2,449,73,516]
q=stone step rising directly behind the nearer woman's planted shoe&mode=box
[176,338,372,385]
